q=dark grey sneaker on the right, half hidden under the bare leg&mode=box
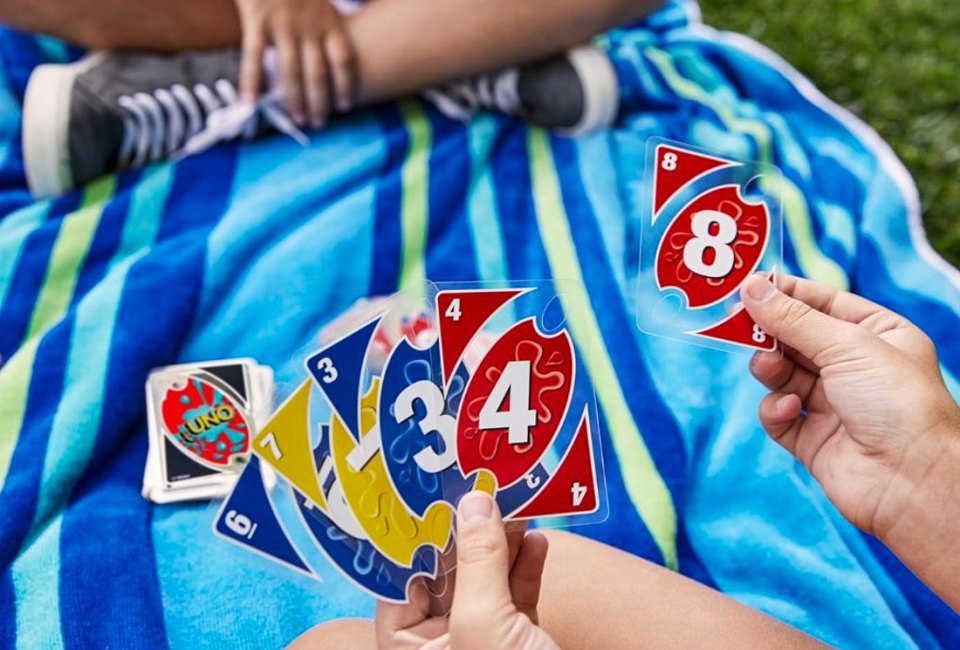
[425,46,620,135]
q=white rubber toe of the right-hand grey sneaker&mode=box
[561,45,620,136]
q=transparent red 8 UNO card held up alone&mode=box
[637,138,782,350]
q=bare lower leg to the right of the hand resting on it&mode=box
[348,0,661,103]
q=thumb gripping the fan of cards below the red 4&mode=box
[450,492,513,647]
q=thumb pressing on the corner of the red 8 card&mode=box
[741,274,861,368]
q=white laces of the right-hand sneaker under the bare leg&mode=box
[423,68,520,122]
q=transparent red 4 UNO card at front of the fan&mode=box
[433,282,607,526]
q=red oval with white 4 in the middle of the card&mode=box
[457,318,575,489]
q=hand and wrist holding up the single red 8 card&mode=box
[743,277,960,611]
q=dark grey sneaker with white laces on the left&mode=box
[23,49,292,197]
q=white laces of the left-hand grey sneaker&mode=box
[117,79,308,168]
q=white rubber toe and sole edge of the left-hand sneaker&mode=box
[23,54,101,199]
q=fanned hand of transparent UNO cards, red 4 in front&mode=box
[213,283,607,602]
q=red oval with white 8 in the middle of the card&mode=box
[656,185,770,309]
